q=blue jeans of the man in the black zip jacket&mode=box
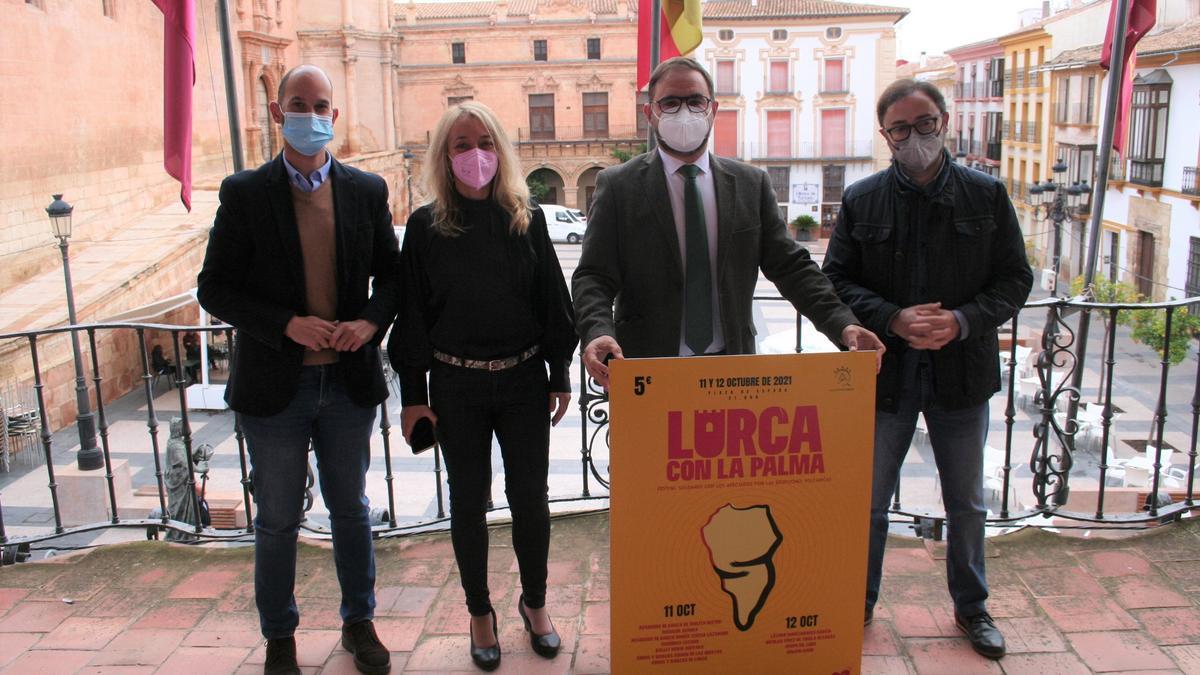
[866,368,989,616]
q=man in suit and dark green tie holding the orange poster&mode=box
[572,58,883,386]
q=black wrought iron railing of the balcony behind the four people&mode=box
[0,297,1200,560]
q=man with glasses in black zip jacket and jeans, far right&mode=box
[823,79,1033,658]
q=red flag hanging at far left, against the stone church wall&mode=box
[154,0,196,211]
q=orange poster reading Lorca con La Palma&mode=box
[610,352,875,675]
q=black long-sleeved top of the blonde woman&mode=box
[388,199,578,406]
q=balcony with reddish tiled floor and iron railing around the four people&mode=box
[0,293,1200,673]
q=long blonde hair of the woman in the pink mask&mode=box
[422,101,529,237]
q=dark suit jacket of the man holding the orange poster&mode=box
[572,151,857,358]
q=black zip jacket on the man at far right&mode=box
[823,155,1033,412]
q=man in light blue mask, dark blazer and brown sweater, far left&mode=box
[198,66,400,674]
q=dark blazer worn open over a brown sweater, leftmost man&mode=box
[197,155,400,417]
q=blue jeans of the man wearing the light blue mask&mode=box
[240,364,376,639]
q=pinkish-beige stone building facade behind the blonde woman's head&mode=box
[394,2,641,208]
